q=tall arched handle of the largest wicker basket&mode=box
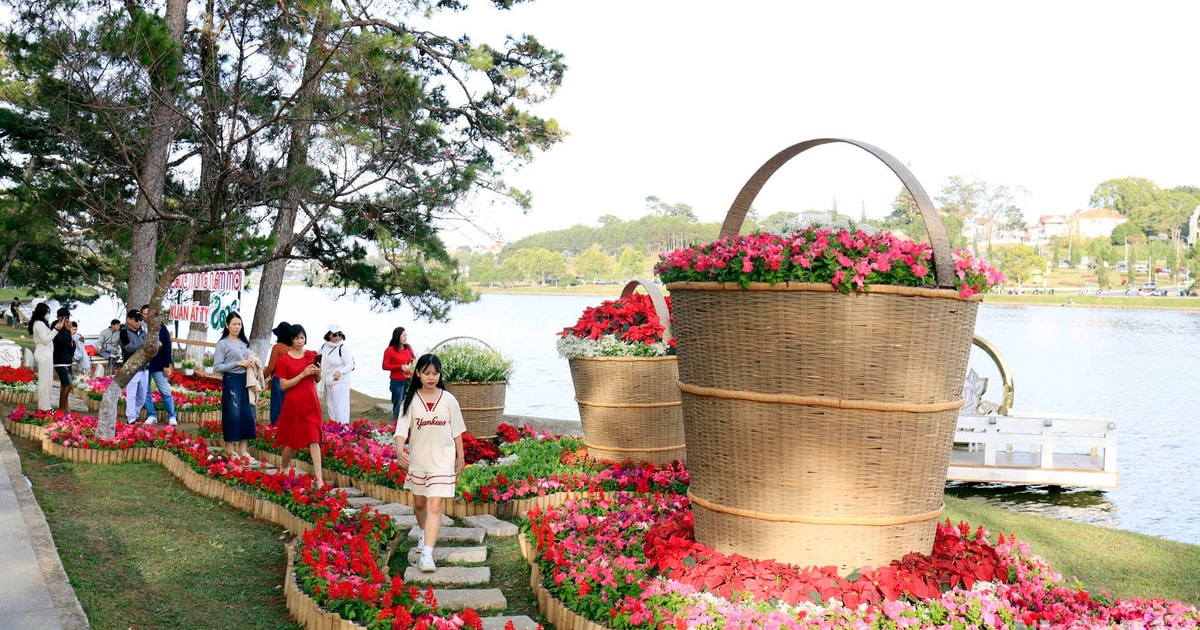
[720,138,954,288]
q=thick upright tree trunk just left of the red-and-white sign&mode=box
[126,0,187,308]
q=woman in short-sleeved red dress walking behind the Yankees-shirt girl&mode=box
[275,324,325,485]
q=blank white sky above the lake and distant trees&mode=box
[427,0,1200,244]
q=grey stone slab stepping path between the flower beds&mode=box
[324,499,538,630]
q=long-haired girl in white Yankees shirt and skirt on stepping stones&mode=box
[396,354,467,572]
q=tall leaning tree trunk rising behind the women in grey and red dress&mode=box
[250,11,331,356]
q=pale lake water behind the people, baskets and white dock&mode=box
[68,287,1200,545]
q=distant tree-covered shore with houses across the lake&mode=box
[456,176,1200,286]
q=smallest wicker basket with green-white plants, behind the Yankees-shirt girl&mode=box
[430,337,512,439]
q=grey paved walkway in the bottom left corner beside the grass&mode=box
[0,422,90,630]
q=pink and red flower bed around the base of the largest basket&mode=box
[529,494,1200,629]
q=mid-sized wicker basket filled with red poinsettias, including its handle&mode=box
[557,281,686,466]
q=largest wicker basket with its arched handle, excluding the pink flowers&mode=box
[667,139,979,572]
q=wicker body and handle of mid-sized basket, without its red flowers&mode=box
[570,280,686,466]
